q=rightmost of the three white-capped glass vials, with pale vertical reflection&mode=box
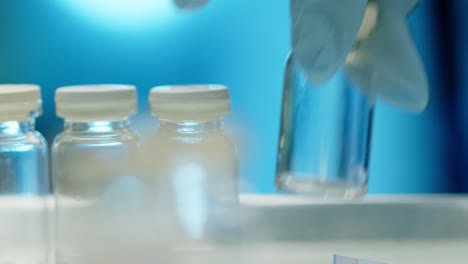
[150,85,239,263]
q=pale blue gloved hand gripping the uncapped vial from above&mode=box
[174,0,429,112]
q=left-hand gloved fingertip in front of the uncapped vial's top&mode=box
[291,0,367,84]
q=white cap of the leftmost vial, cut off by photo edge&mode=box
[0,84,42,121]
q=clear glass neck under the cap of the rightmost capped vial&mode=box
[159,118,224,134]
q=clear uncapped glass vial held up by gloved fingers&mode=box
[276,1,378,199]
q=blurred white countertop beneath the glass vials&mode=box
[0,195,468,264]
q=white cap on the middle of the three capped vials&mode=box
[55,84,137,121]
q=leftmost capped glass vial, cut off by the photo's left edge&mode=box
[0,84,49,264]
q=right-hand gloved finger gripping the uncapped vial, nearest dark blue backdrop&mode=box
[367,0,429,112]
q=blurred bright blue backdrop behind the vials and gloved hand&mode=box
[0,0,468,193]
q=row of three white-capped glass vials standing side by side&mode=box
[0,85,238,264]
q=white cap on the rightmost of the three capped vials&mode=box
[150,84,231,120]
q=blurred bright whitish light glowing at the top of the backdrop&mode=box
[59,0,174,31]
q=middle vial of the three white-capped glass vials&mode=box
[52,85,147,264]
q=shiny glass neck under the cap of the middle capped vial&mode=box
[64,118,130,133]
